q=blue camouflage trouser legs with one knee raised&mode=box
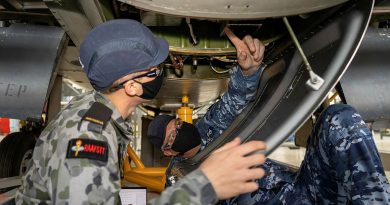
[220,105,390,205]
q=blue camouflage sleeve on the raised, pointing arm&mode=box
[165,65,264,187]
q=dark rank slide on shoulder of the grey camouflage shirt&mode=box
[82,102,112,133]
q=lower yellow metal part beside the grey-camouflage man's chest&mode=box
[122,146,167,192]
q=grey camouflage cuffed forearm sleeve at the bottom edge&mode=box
[148,170,218,205]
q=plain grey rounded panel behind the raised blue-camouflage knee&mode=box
[340,28,390,121]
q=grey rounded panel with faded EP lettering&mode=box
[0,24,67,121]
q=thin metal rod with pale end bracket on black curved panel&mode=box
[283,17,325,90]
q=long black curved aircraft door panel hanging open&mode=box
[175,0,373,174]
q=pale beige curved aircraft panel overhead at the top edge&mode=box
[120,0,346,20]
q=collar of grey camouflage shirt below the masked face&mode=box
[94,91,133,139]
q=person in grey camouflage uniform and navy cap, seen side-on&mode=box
[15,19,265,205]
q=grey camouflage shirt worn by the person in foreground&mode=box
[15,92,217,205]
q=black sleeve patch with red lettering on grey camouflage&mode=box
[66,138,108,162]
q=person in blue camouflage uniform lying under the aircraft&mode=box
[148,24,390,205]
